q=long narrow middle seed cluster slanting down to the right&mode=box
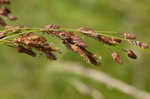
[46,25,99,65]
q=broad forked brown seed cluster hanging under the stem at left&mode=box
[14,33,57,60]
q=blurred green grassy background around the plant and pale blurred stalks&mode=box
[0,0,150,99]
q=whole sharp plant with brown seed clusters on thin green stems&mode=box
[0,0,149,65]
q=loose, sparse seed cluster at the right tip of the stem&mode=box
[78,27,149,64]
